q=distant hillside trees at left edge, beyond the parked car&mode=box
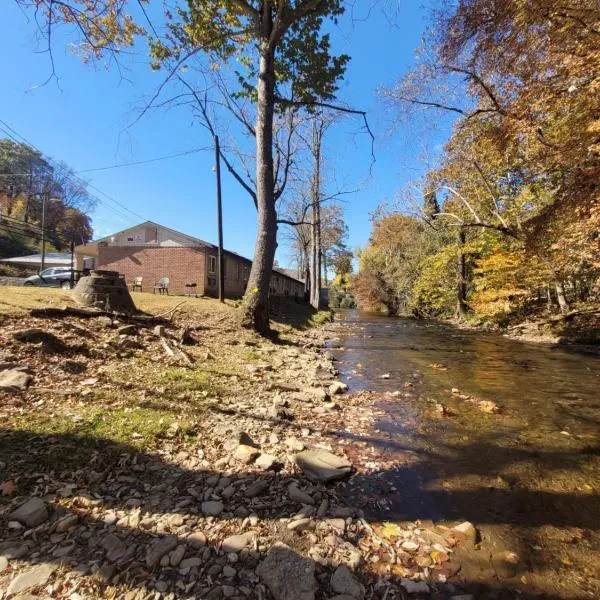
[0,139,95,250]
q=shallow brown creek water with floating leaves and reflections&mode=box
[330,311,600,598]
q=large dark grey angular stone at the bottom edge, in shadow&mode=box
[256,542,317,600]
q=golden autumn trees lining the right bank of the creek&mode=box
[357,0,600,319]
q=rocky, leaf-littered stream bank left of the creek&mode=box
[0,296,584,600]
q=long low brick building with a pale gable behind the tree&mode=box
[75,221,304,299]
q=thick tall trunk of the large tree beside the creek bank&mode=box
[241,42,277,334]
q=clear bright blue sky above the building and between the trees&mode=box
[0,0,450,264]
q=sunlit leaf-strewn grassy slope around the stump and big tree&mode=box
[0,287,330,478]
